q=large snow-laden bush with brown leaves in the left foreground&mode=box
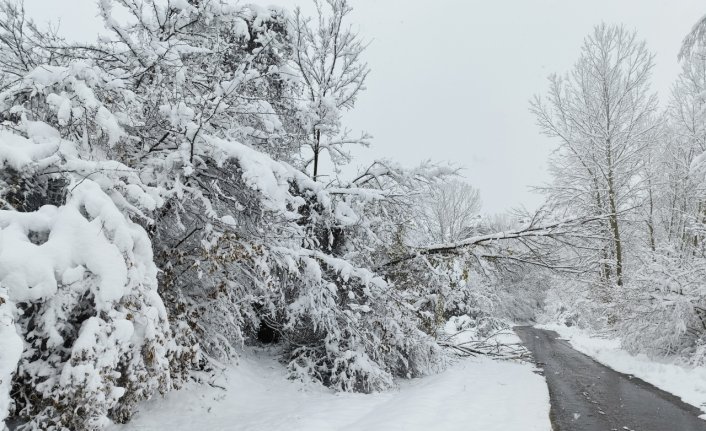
[0,121,178,430]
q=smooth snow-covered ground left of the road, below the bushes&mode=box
[110,351,551,431]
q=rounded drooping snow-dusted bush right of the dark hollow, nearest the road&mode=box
[282,246,441,392]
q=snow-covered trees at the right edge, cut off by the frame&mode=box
[616,17,706,365]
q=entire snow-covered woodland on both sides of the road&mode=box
[0,0,706,431]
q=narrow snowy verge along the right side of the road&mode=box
[537,324,706,419]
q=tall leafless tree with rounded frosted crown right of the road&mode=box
[532,24,657,286]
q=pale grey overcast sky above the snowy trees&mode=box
[25,0,706,213]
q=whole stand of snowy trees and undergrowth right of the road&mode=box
[533,20,706,365]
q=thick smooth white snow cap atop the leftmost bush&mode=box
[0,180,136,304]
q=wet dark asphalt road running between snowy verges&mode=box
[515,326,706,431]
